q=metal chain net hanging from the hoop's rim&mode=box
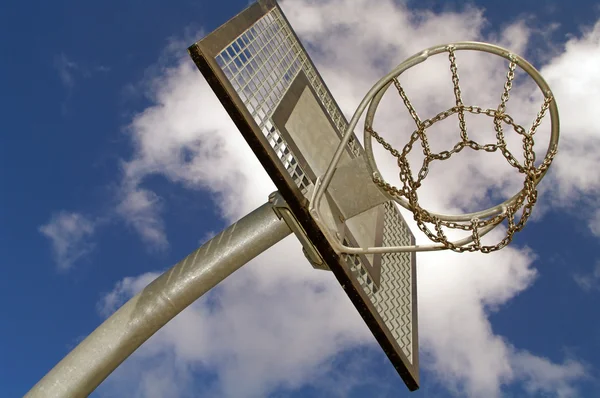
[365,46,557,253]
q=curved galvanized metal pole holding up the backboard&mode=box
[25,202,291,398]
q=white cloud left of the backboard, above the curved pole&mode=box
[118,53,274,245]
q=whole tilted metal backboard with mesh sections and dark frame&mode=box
[189,0,419,390]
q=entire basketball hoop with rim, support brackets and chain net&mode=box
[309,42,559,254]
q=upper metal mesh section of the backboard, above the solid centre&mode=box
[215,8,362,194]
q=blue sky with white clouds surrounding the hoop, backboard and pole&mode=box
[0,0,600,397]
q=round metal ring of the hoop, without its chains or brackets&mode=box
[354,42,559,222]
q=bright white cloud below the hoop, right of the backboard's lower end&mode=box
[418,248,536,397]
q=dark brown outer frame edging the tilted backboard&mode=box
[188,0,419,391]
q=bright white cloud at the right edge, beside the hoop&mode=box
[542,22,600,213]
